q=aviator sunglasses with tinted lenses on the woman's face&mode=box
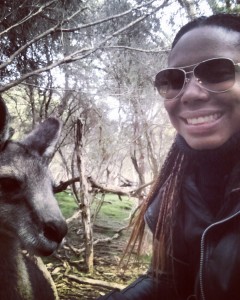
[155,57,240,100]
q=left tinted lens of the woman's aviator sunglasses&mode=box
[155,69,185,99]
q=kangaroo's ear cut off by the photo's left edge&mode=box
[0,96,9,148]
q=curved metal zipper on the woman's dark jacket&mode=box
[199,211,240,300]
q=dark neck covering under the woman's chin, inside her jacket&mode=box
[176,133,240,217]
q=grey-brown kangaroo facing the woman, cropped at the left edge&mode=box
[0,98,67,300]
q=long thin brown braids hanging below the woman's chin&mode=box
[124,142,188,271]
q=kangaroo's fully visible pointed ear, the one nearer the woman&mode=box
[21,118,61,159]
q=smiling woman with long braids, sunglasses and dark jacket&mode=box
[97,14,240,300]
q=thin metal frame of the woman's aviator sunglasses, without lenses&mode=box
[154,57,240,101]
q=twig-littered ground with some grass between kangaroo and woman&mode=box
[45,195,149,300]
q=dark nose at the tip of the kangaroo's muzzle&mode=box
[43,221,67,244]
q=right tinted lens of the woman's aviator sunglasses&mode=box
[194,58,235,92]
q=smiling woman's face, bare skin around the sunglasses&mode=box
[164,26,240,150]
